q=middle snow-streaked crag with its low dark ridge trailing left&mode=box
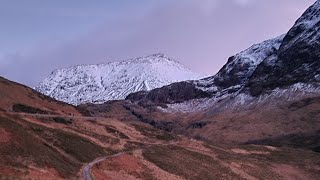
[126,35,284,105]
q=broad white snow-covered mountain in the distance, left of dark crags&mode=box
[35,54,204,105]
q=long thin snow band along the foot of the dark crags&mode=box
[159,83,320,113]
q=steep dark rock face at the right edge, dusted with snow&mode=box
[247,1,320,96]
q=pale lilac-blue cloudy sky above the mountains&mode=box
[0,0,315,87]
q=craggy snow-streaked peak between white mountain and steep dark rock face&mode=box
[195,35,285,92]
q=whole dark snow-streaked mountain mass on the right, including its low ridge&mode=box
[127,0,320,110]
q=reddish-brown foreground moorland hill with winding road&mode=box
[0,76,320,179]
